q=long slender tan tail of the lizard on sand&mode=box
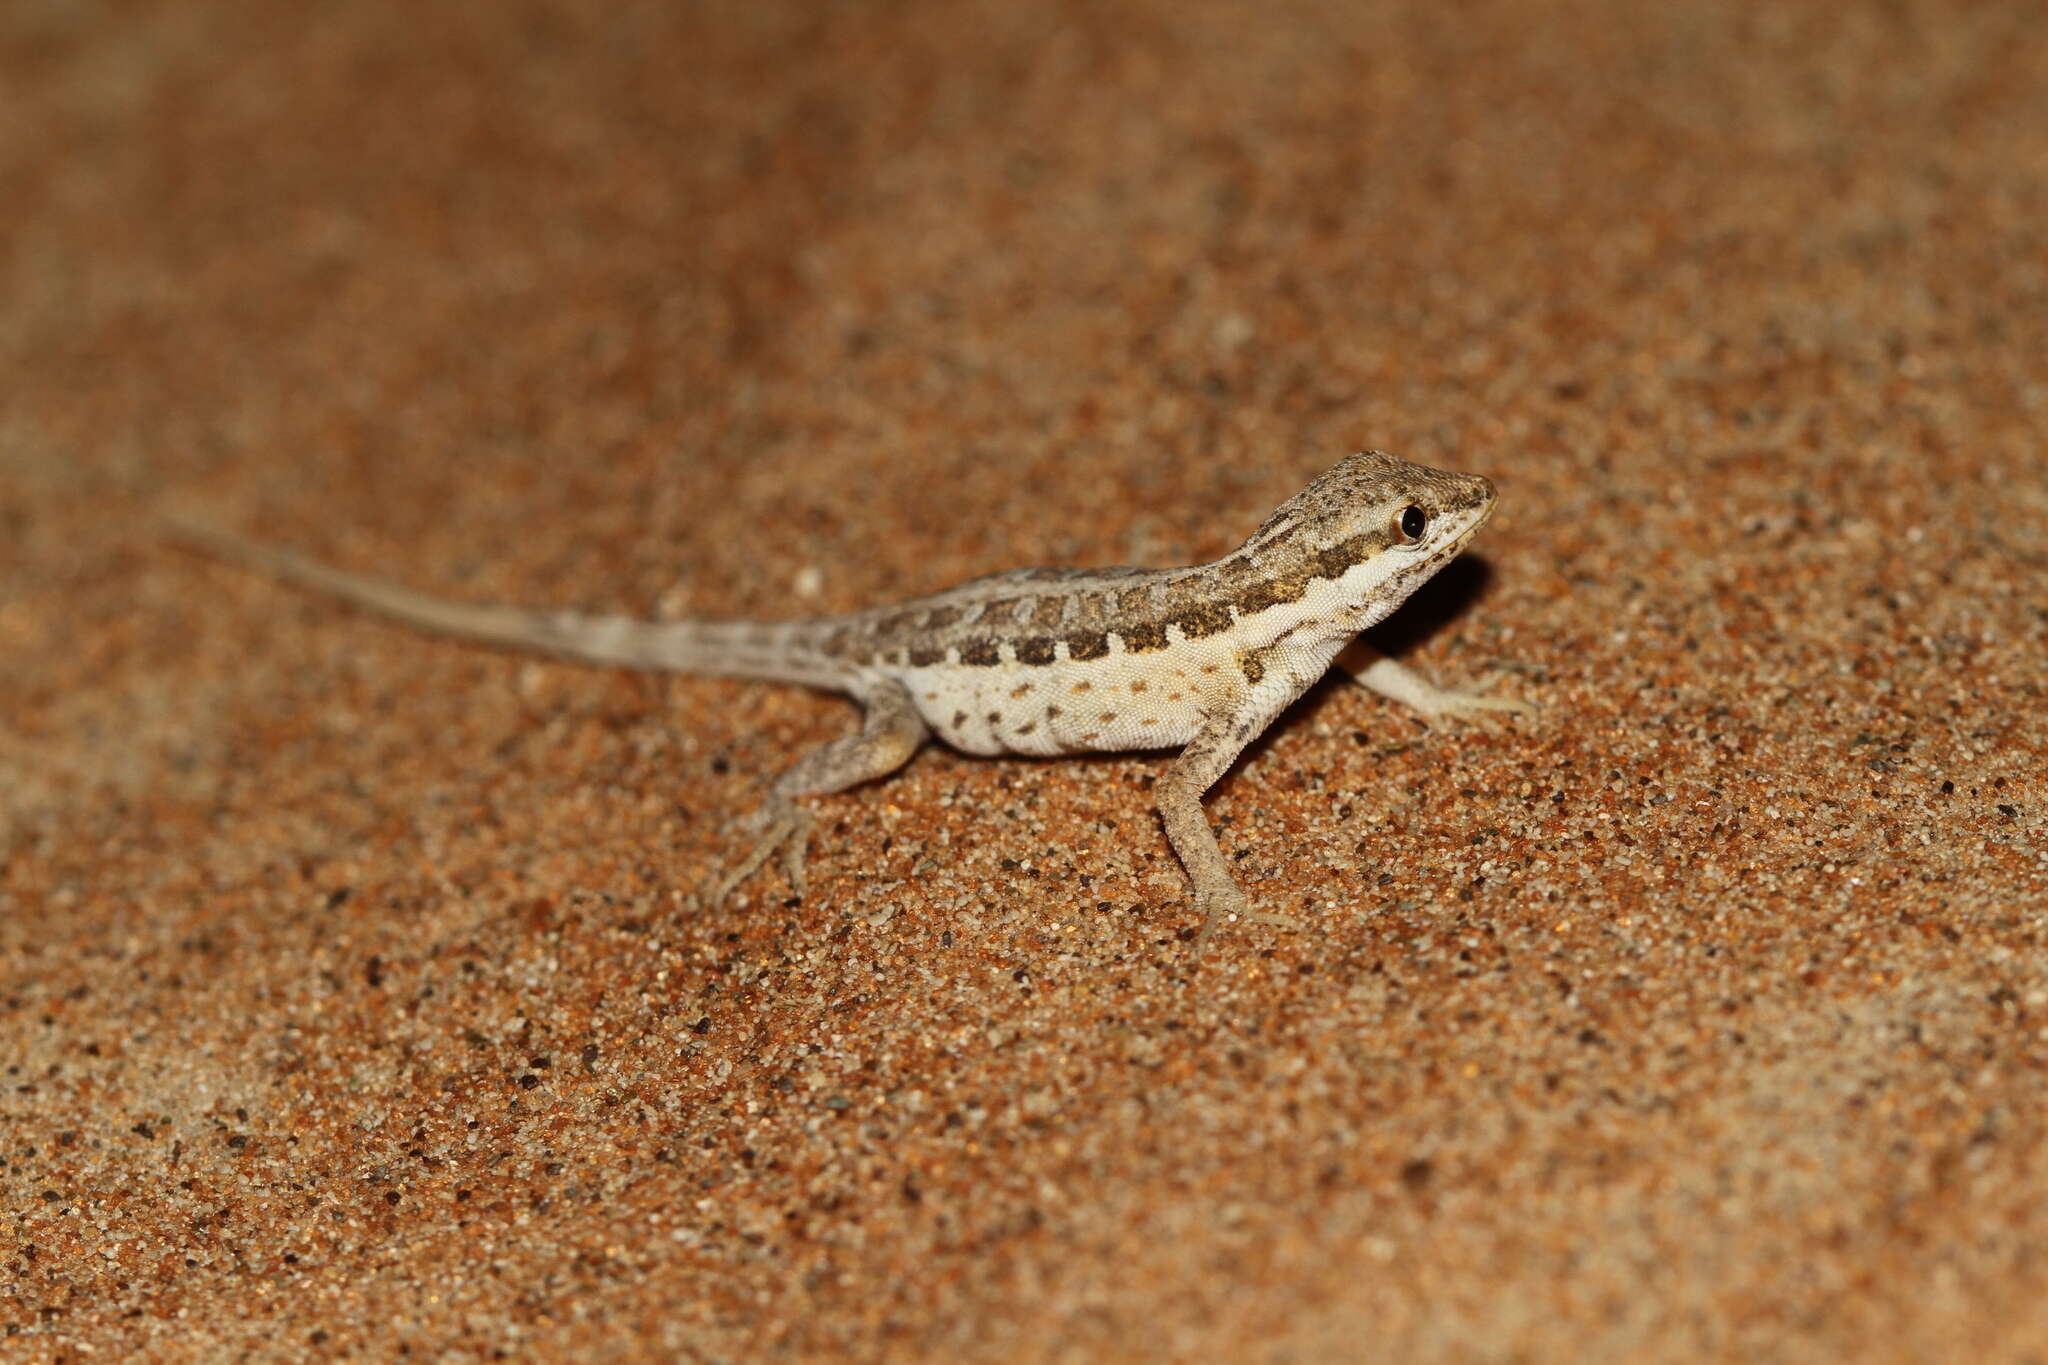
[166,520,844,688]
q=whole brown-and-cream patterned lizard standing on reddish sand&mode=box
[172,450,1532,954]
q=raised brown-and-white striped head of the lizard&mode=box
[1239,450,1495,630]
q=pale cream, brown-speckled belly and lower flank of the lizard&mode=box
[901,647,1231,753]
